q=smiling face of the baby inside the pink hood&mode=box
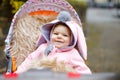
[50,25,71,48]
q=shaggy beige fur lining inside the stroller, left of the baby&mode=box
[10,15,56,66]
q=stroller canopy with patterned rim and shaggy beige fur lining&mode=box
[4,0,81,72]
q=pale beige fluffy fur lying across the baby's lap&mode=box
[29,56,75,72]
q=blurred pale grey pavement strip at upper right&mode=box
[87,8,120,24]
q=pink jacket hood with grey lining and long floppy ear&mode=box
[37,11,87,60]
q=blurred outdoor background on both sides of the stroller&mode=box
[0,0,120,73]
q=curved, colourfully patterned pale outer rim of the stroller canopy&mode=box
[4,0,81,72]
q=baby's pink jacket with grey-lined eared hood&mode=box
[16,12,91,74]
